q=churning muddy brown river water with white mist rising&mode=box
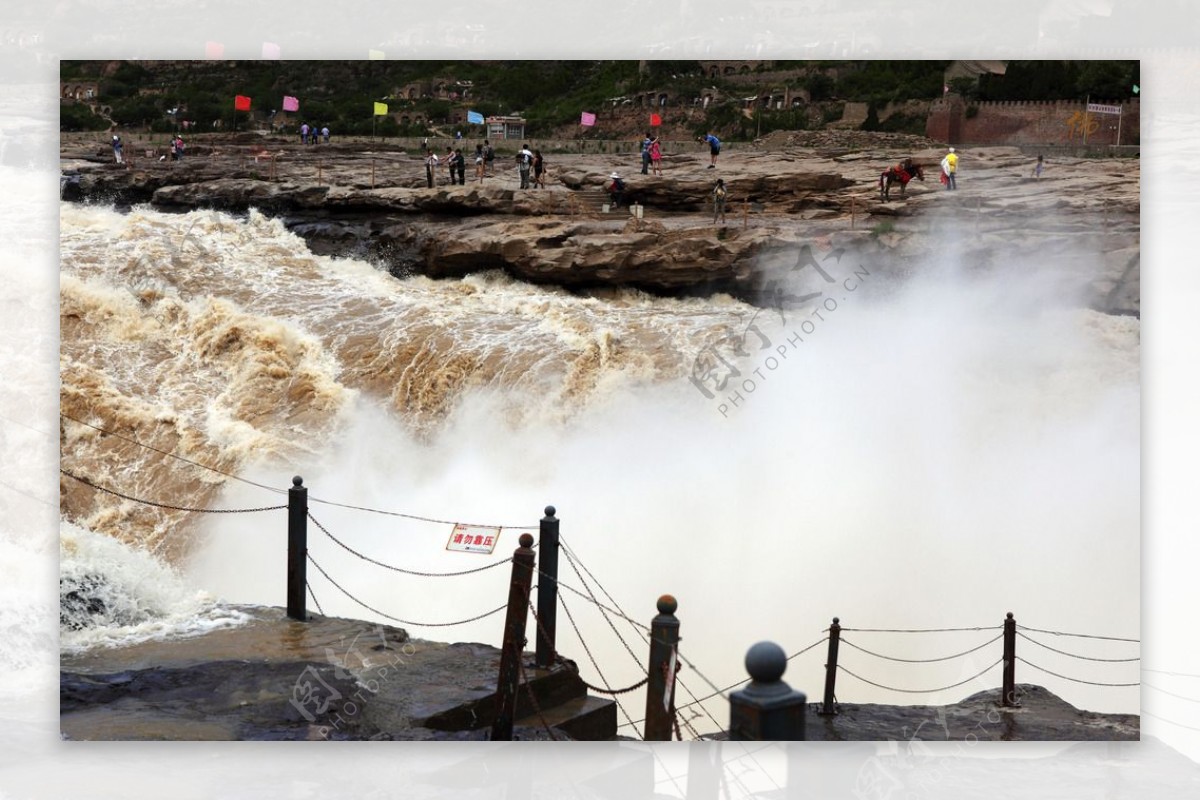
[60,196,1140,730]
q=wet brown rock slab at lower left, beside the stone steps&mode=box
[60,609,585,740]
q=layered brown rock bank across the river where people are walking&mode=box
[61,132,1140,315]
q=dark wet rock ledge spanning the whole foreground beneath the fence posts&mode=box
[60,608,1140,741]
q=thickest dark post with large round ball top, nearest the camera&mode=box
[730,642,808,740]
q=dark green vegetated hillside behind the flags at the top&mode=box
[60,60,1139,140]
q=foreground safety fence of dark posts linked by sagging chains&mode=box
[60,415,1152,740]
